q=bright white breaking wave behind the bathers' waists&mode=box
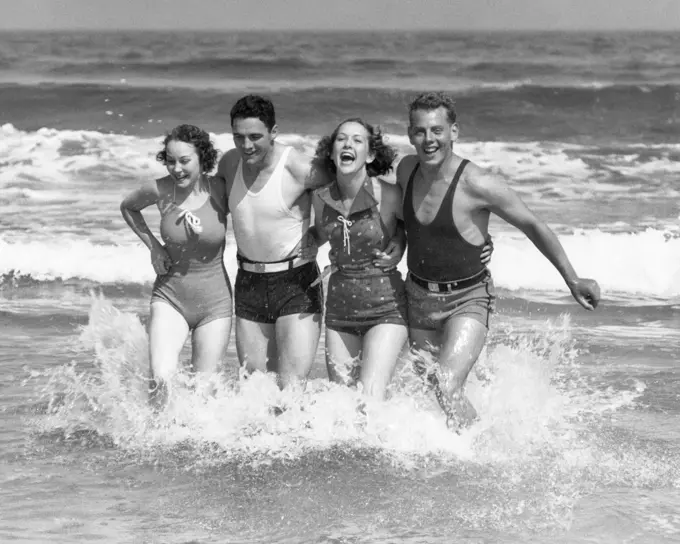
[0,229,680,299]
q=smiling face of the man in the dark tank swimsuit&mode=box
[408,107,458,166]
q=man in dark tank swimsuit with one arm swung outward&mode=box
[397,93,600,429]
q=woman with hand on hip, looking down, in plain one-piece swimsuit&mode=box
[120,125,232,407]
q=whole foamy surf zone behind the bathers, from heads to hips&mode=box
[0,124,680,299]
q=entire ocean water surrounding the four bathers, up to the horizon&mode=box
[0,32,680,544]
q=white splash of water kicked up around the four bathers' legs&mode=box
[29,297,639,462]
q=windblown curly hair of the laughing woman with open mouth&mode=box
[314,117,397,176]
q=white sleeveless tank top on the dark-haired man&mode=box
[229,147,309,263]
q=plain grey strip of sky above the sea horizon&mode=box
[0,0,680,30]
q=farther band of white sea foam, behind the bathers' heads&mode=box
[0,124,680,189]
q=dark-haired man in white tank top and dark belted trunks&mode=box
[218,95,327,387]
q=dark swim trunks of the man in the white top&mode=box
[234,261,323,323]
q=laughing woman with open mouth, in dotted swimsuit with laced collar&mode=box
[313,118,408,399]
